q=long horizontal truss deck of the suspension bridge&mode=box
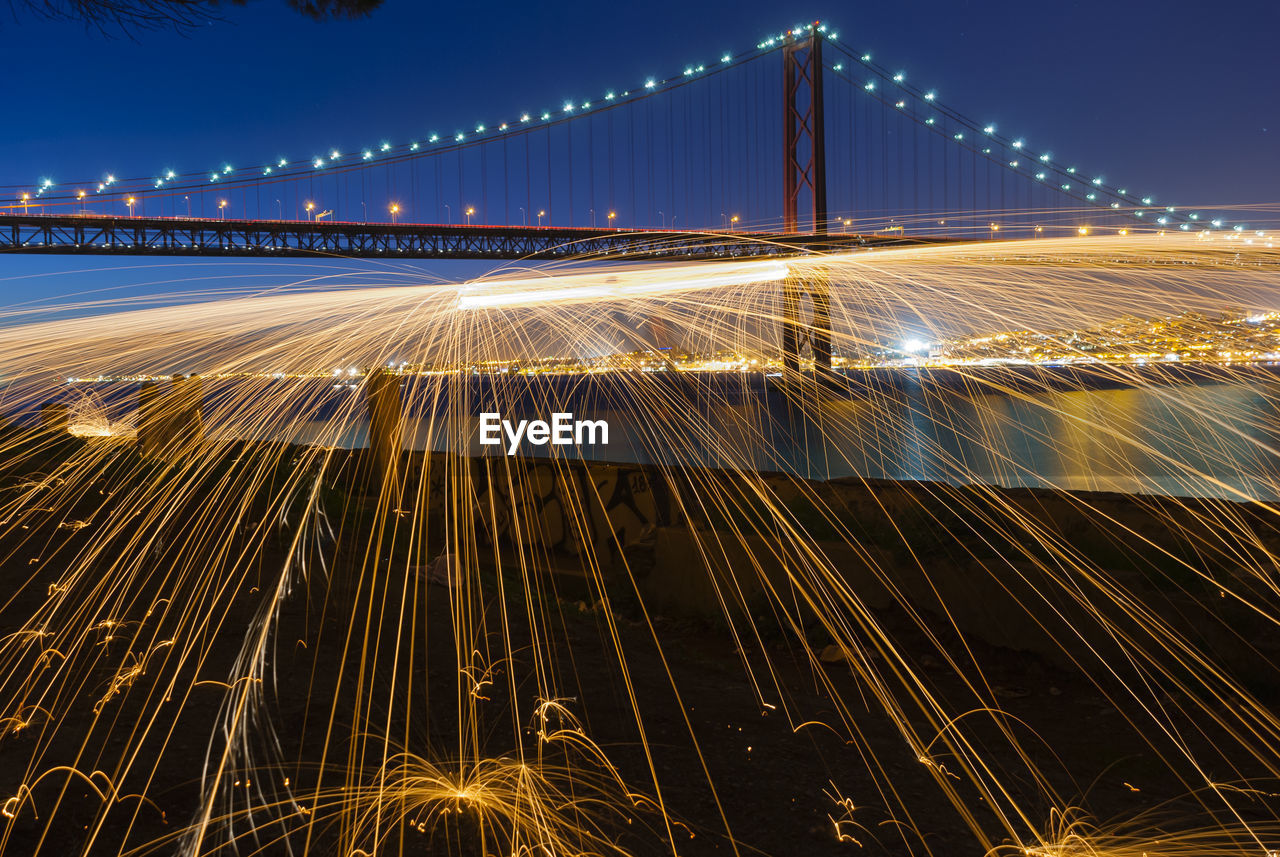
[0,214,946,261]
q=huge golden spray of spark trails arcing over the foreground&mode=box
[0,234,1280,857]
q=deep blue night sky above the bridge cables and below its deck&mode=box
[0,0,1280,313]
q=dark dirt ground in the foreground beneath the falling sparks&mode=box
[0,440,1276,857]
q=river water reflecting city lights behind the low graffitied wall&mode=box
[267,366,1280,500]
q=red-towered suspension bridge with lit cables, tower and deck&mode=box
[0,22,1243,365]
